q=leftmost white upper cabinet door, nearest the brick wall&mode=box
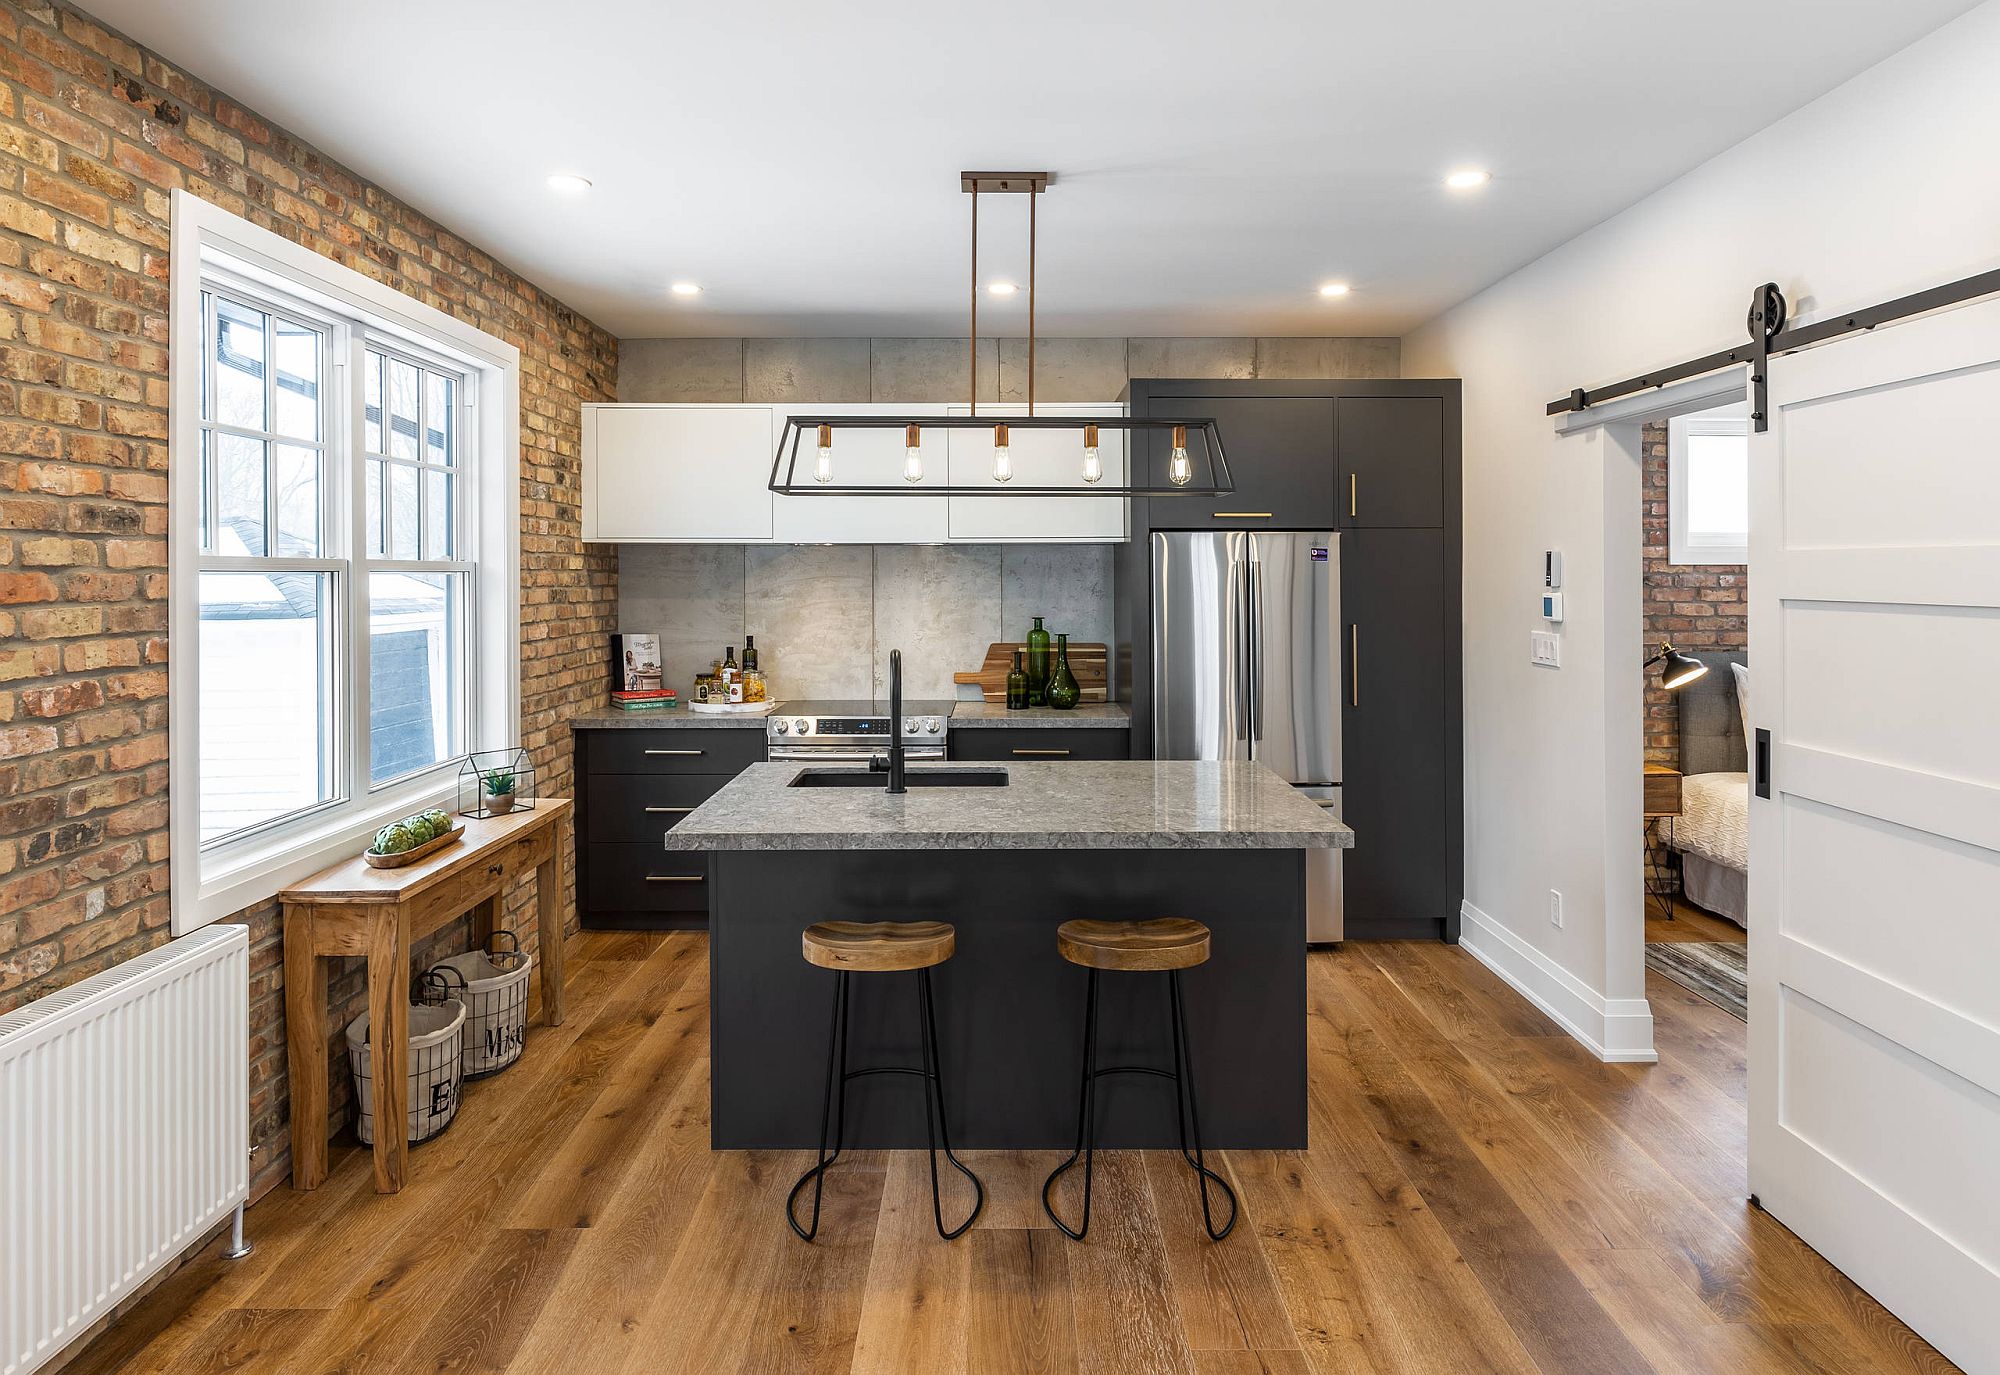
[584,406,778,544]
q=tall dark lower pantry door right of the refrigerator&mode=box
[1340,530,1460,939]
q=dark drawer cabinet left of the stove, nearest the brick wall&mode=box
[576,721,764,931]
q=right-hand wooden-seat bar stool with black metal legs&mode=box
[1042,917,1236,1241]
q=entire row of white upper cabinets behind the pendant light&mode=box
[582,402,1130,544]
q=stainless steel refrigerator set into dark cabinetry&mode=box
[1152,530,1344,941]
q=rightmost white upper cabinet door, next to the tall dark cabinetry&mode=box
[950,402,1130,544]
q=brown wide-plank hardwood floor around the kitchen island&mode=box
[70,923,1952,1375]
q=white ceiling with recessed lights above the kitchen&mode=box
[84,0,1972,338]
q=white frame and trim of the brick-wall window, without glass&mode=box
[168,190,520,935]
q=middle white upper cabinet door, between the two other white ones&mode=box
[772,404,950,544]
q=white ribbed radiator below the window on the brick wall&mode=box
[0,925,250,1375]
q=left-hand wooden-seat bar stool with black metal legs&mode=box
[784,921,986,1241]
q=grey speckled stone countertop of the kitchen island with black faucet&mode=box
[666,759,1354,849]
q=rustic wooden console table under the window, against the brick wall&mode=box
[278,797,570,1193]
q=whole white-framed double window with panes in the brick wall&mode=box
[168,194,520,931]
